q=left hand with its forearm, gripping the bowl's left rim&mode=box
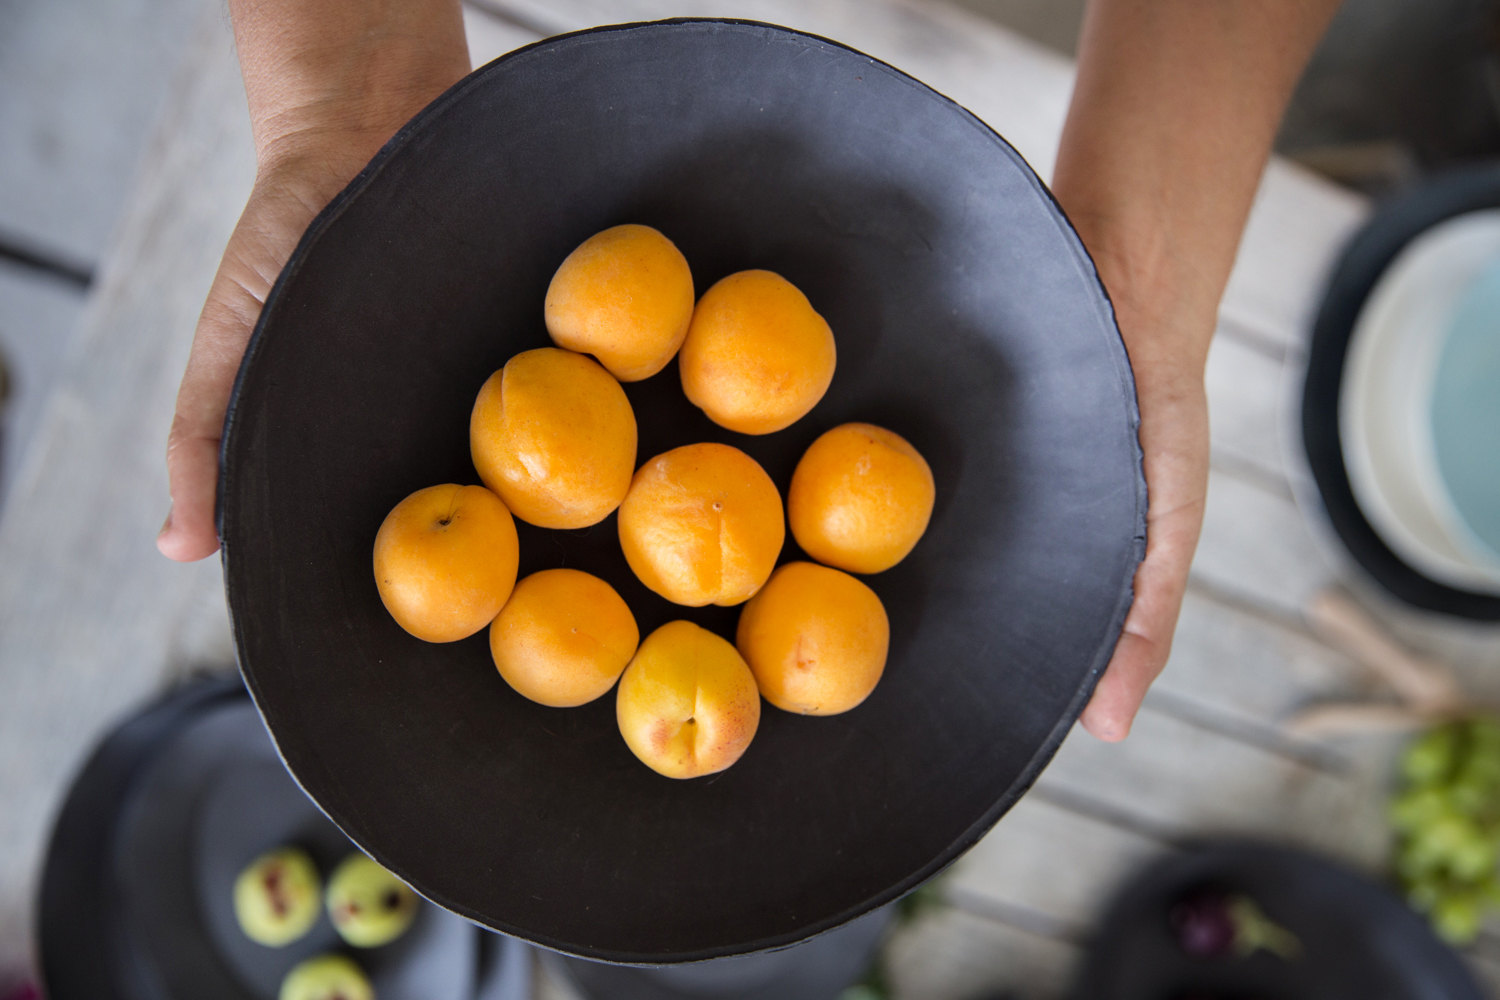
[156,0,470,561]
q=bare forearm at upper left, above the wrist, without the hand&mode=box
[230,0,470,171]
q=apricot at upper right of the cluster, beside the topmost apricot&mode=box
[678,271,836,435]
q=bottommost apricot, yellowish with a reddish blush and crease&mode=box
[615,621,761,778]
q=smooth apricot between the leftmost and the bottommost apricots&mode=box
[489,570,641,708]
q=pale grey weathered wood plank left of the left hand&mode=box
[0,10,254,964]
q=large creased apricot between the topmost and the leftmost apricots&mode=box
[470,348,636,528]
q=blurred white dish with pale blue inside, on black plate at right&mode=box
[1338,208,1500,595]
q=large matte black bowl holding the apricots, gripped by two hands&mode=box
[221,21,1146,963]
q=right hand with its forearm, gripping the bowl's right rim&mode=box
[1052,0,1338,741]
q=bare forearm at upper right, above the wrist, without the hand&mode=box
[1053,0,1338,360]
